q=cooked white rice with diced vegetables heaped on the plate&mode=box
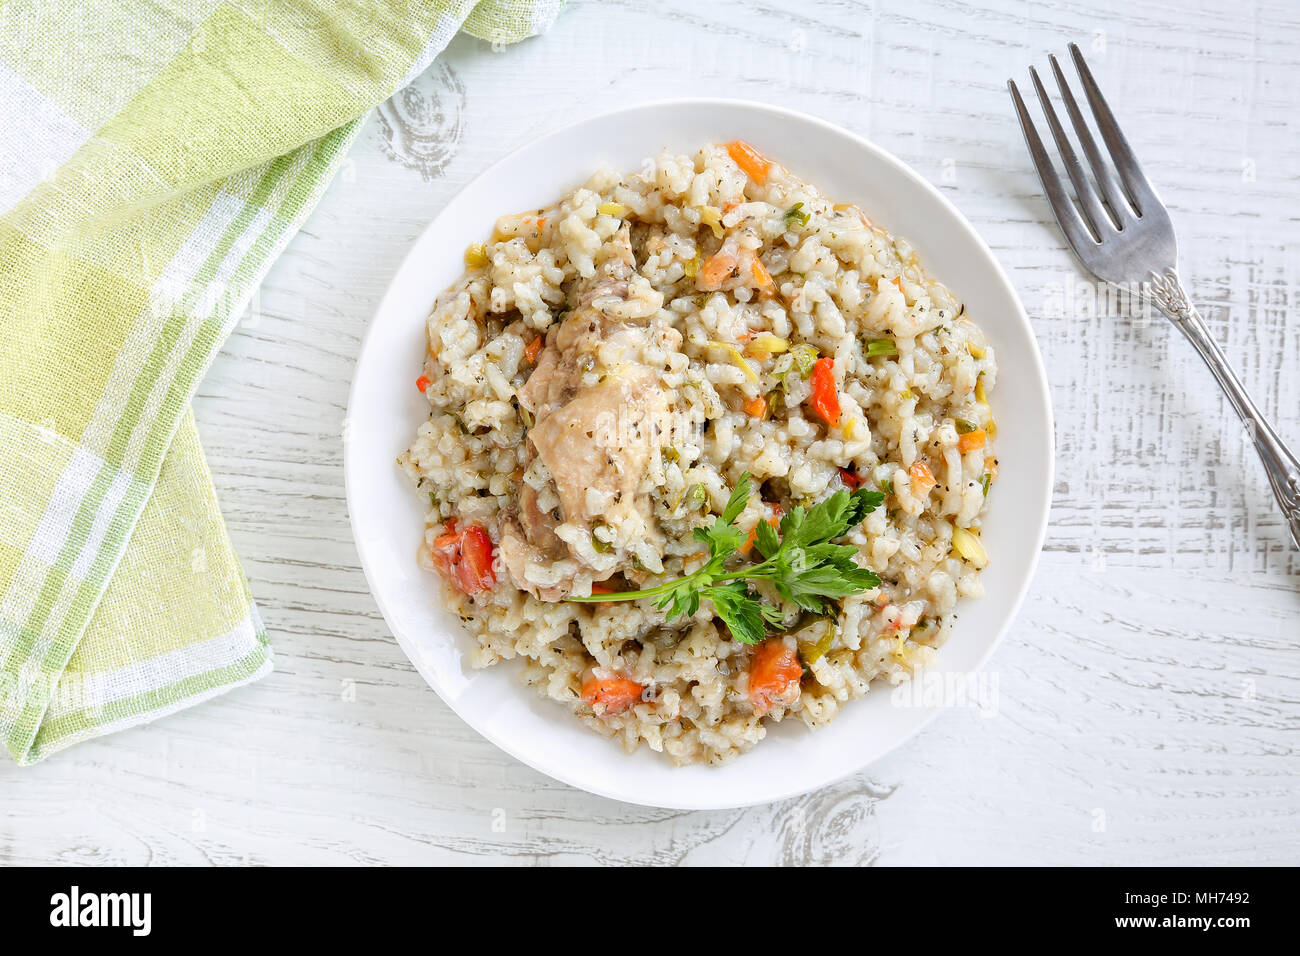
[399,146,997,763]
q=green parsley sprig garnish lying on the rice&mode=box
[567,472,884,644]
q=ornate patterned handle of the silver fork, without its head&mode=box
[1149,269,1300,548]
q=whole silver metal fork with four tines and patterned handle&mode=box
[1006,43,1300,548]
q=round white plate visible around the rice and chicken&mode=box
[346,100,1053,809]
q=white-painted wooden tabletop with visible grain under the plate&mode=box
[0,0,1300,864]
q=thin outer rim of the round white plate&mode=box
[343,96,1056,810]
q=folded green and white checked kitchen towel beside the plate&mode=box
[0,0,560,763]
